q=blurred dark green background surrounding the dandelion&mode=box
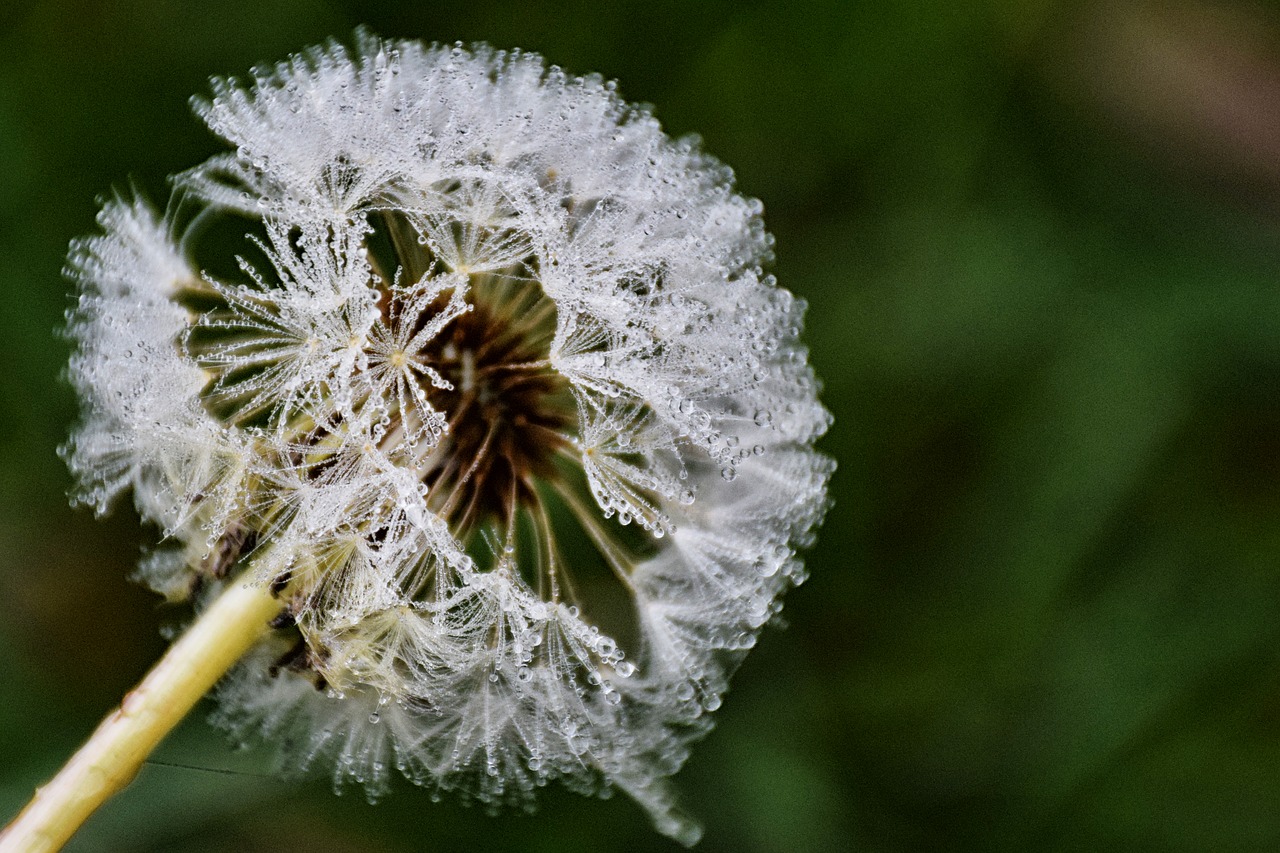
[0,0,1280,853]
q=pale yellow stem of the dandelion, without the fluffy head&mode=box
[0,573,280,853]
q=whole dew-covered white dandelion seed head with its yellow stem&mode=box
[6,33,833,849]
